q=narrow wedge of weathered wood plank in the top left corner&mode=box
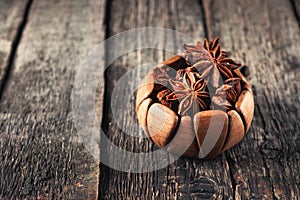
[0,0,29,92]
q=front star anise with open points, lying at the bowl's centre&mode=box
[166,73,210,115]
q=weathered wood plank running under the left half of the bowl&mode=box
[99,0,233,199]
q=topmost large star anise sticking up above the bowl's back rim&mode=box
[183,37,240,88]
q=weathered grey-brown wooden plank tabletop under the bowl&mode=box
[0,0,300,199]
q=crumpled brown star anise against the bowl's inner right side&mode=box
[212,78,241,110]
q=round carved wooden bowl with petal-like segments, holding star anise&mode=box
[136,40,254,159]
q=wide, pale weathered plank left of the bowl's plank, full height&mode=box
[0,0,105,199]
